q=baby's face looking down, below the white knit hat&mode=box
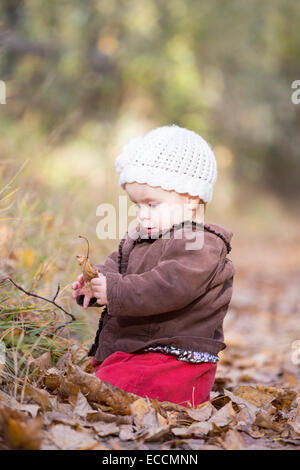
[125,182,199,234]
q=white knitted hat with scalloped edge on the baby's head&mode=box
[115,124,217,203]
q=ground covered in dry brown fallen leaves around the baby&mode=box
[0,240,300,450]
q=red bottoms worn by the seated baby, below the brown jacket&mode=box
[92,351,217,407]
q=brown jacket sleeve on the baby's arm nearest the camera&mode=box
[106,233,222,316]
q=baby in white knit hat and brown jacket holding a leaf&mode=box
[72,125,235,406]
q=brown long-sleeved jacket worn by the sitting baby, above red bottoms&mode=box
[76,222,235,362]
